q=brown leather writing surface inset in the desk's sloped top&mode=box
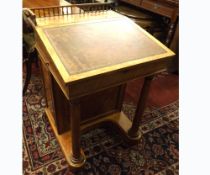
[44,19,166,75]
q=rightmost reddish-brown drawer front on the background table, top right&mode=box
[141,0,174,17]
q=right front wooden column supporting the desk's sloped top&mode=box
[128,76,153,140]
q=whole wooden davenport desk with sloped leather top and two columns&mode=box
[28,3,174,168]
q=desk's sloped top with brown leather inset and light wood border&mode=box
[36,11,174,96]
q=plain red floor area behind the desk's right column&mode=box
[125,74,179,107]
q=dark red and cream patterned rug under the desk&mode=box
[23,74,179,175]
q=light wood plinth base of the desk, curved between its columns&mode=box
[45,108,142,169]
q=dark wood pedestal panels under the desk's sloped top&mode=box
[48,77,125,134]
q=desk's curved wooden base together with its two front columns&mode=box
[45,76,153,170]
